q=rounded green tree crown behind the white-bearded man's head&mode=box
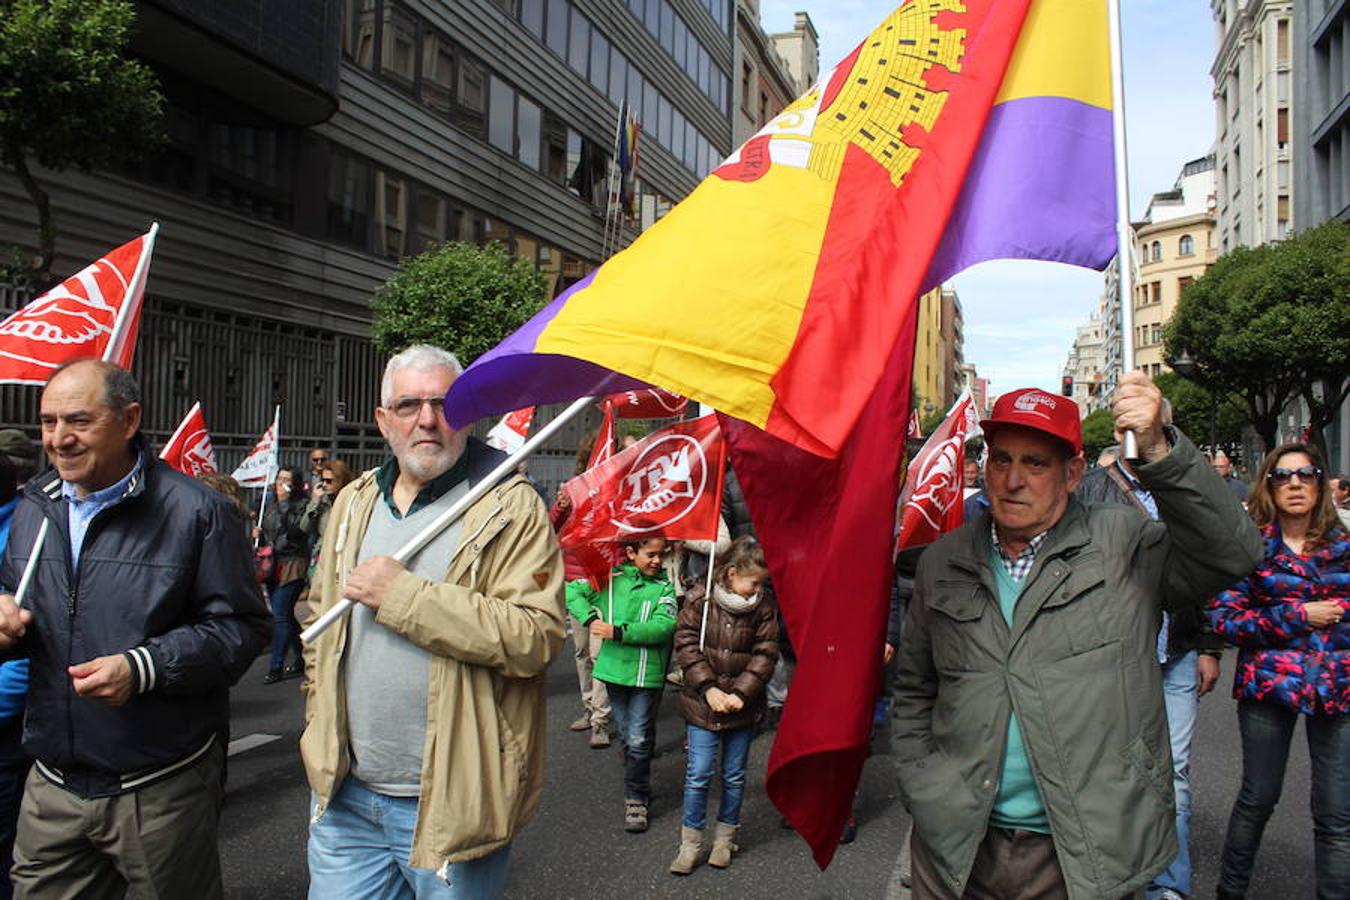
[374,243,545,366]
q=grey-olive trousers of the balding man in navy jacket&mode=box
[11,745,224,900]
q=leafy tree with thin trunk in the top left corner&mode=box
[0,0,163,287]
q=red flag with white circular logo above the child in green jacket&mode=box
[558,416,726,584]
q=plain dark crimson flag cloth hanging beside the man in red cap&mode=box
[722,312,918,869]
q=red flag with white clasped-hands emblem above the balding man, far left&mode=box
[0,225,159,385]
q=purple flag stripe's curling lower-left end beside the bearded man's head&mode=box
[446,273,647,428]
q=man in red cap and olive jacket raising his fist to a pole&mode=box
[894,372,1261,900]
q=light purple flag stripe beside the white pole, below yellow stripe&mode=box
[925,97,1116,290]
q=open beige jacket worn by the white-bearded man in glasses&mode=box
[300,461,564,869]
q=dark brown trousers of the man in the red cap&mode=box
[910,827,1069,900]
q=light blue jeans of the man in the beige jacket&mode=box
[309,777,510,900]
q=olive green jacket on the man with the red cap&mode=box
[894,429,1261,900]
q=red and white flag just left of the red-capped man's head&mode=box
[896,393,979,551]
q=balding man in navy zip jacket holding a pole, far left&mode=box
[0,362,269,900]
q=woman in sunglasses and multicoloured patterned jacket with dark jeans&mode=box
[1210,444,1350,899]
